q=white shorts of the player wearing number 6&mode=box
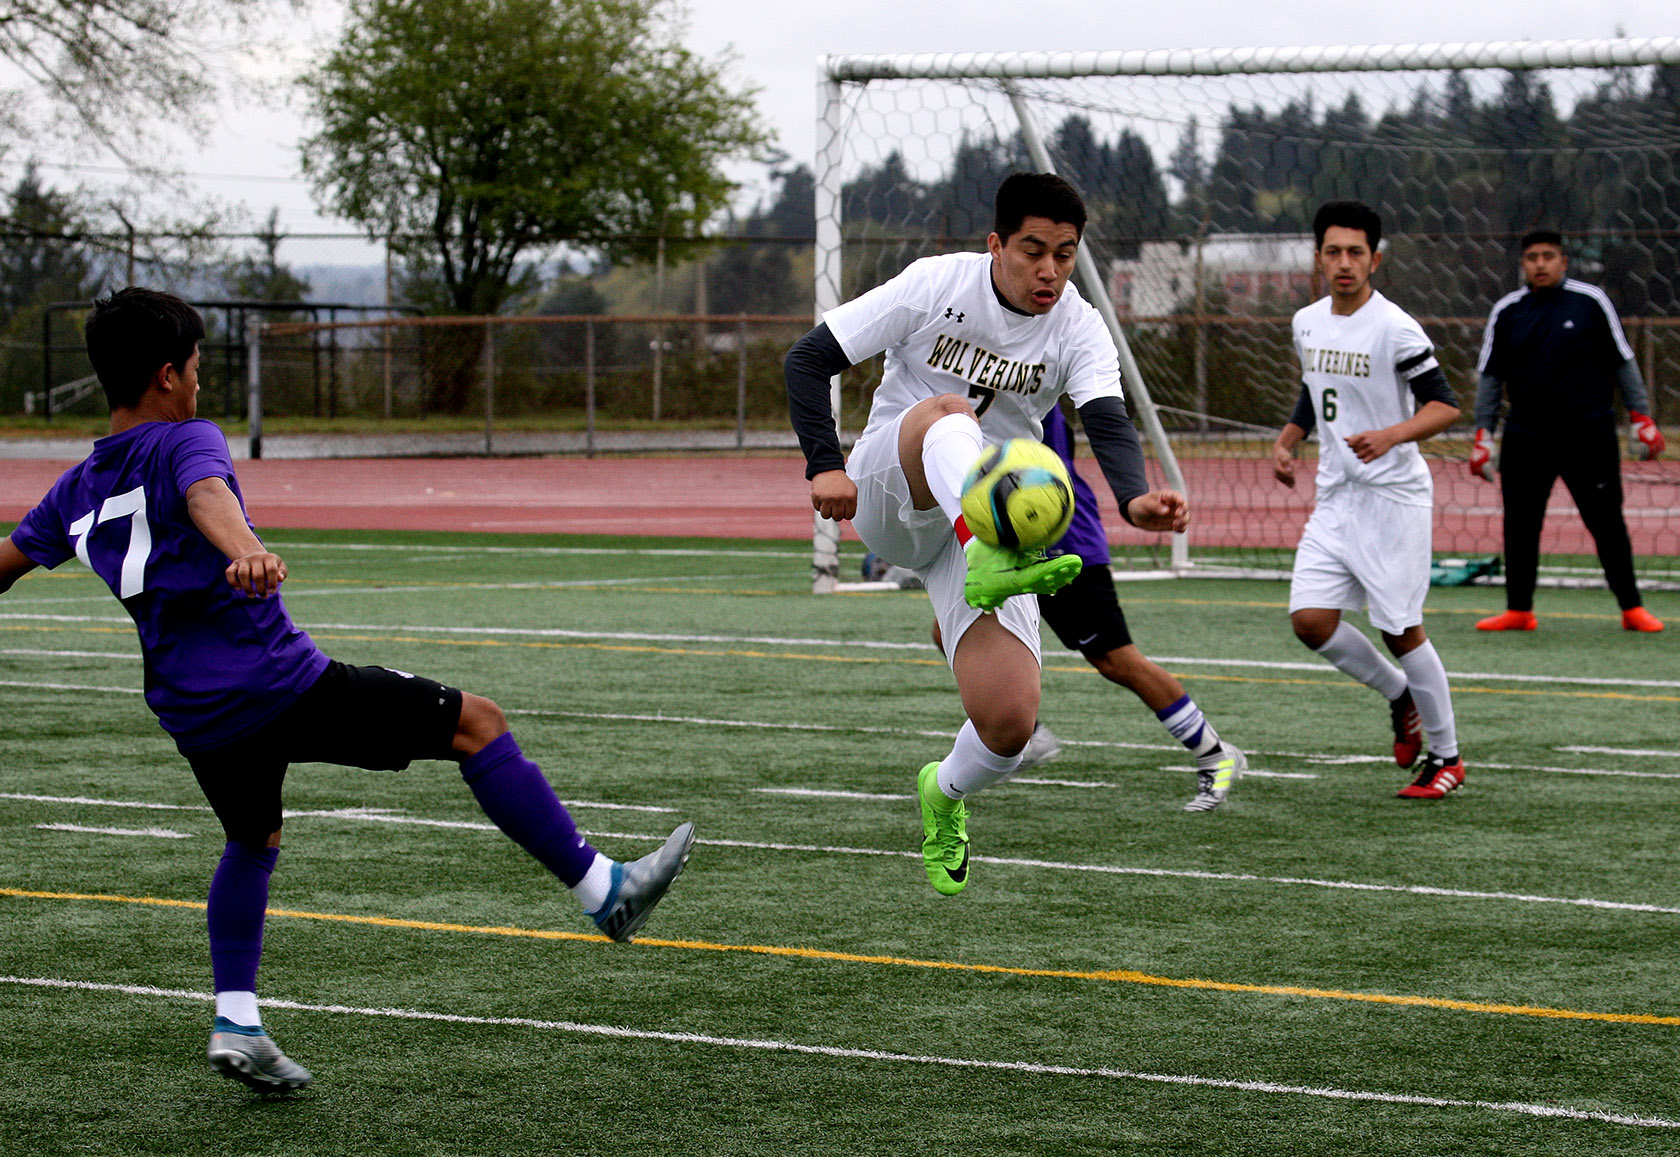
[1289,487,1435,635]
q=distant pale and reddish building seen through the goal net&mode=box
[1109,233,1314,319]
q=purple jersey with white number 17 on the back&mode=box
[12,420,329,751]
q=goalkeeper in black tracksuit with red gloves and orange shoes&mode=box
[1470,230,1663,631]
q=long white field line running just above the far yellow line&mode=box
[0,614,1680,690]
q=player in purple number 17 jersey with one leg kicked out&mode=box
[0,289,694,1092]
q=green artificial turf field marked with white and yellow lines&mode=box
[0,531,1680,1157]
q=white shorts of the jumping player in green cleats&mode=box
[845,410,1043,665]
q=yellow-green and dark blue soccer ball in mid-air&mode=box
[963,438,1074,551]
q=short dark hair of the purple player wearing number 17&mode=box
[82,285,205,410]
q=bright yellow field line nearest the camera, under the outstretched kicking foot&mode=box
[0,888,1680,1024]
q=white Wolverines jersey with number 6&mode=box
[1294,291,1440,505]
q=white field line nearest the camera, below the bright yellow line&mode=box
[0,976,1680,1128]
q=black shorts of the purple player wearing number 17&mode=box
[181,662,460,843]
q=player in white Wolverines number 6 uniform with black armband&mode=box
[1272,202,1465,799]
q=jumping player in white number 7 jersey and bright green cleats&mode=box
[785,173,1189,895]
